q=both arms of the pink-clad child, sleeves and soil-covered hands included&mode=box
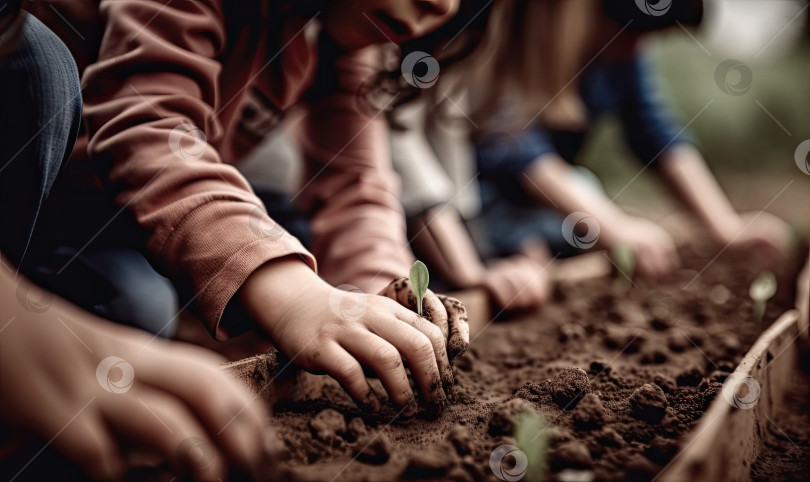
[84,0,469,406]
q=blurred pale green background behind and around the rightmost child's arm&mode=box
[580,0,810,234]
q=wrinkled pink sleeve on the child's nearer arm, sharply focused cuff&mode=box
[83,0,315,339]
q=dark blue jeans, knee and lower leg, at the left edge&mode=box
[0,14,178,336]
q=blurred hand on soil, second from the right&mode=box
[602,216,680,278]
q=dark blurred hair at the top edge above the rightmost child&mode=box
[603,0,703,32]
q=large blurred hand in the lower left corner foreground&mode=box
[0,286,272,480]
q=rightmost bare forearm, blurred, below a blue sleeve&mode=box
[660,145,742,242]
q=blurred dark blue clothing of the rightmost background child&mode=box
[476,51,691,255]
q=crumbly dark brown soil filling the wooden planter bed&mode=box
[273,245,807,480]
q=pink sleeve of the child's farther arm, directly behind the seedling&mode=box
[298,47,413,293]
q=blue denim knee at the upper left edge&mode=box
[0,14,82,268]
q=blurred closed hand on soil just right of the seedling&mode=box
[484,254,551,311]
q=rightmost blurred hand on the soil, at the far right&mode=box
[719,212,792,265]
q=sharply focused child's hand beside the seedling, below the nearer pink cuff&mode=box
[239,259,454,416]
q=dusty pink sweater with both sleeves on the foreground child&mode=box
[30,0,412,339]
